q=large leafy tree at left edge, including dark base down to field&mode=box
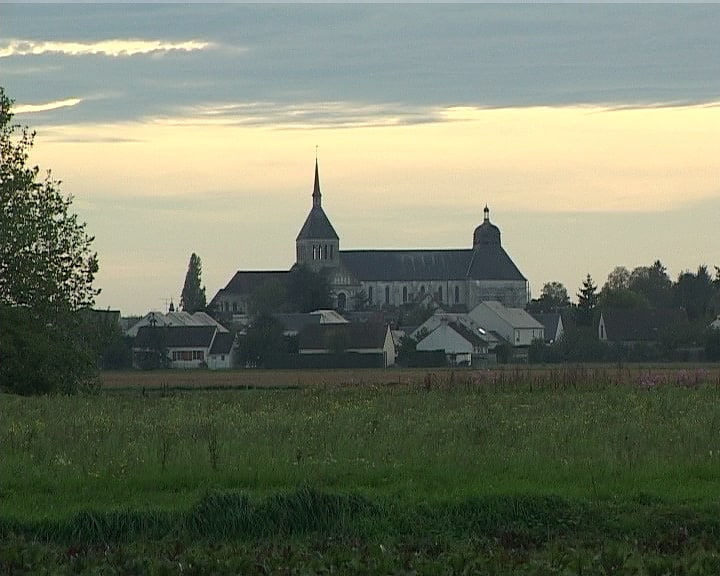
[0,87,99,394]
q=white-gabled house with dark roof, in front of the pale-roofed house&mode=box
[416,320,489,366]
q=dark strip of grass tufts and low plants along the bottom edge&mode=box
[0,488,720,575]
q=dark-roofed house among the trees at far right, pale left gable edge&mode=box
[598,308,688,346]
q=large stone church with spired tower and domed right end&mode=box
[211,159,529,315]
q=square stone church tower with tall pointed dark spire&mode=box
[295,158,340,271]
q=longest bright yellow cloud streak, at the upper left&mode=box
[0,39,211,58]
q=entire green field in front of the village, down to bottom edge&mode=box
[0,366,720,574]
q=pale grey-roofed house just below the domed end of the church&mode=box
[468,300,545,348]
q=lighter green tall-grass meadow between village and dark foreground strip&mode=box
[0,367,720,521]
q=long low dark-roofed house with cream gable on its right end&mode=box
[298,323,397,367]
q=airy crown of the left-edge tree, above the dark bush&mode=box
[0,87,99,321]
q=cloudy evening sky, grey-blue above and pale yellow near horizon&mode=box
[0,2,720,315]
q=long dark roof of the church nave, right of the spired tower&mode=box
[340,244,525,282]
